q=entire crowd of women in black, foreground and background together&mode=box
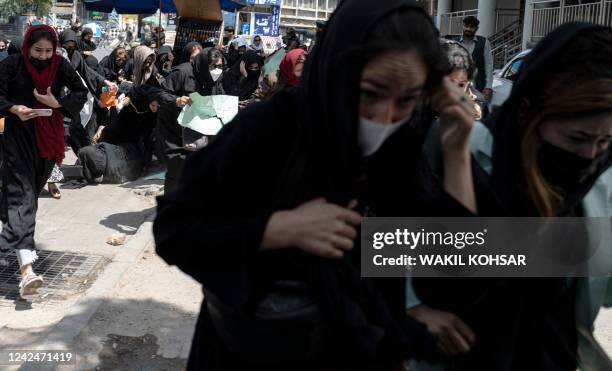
[0,0,612,371]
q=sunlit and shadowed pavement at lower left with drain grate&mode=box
[0,153,202,370]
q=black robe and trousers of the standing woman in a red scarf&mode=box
[0,54,87,253]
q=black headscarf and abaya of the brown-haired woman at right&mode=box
[413,24,612,371]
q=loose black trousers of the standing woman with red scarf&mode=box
[0,117,55,250]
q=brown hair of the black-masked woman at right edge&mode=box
[519,30,612,216]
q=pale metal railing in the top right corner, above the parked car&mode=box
[531,0,612,41]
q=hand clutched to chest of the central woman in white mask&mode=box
[262,198,361,259]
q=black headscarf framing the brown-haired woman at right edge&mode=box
[487,23,612,215]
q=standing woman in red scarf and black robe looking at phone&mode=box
[0,25,87,296]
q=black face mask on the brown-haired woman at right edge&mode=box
[539,141,606,191]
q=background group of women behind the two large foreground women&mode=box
[0,19,303,297]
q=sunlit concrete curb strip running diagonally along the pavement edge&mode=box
[20,212,155,370]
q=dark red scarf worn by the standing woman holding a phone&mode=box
[21,25,65,166]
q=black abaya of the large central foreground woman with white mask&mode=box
[154,0,470,370]
